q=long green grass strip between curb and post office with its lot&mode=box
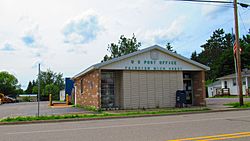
[0,107,209,122]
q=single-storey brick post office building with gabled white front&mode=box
[73,45,209,109]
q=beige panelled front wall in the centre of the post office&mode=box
[122,71,183,109]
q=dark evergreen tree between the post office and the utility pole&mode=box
[191,29,234,80]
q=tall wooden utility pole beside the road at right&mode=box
[234,0,244,106]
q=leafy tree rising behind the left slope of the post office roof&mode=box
[102,34,141,62]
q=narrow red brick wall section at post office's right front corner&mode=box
[192,71,206,106]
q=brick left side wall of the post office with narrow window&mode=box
[75,70,101,108]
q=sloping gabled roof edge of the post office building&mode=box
[72,45,210,79]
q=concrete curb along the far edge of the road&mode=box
[0,108,250,126]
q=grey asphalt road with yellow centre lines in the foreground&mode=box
[0,110,250,141]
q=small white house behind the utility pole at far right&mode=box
[208,70,250,97]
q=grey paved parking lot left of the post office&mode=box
[0,101,90,118]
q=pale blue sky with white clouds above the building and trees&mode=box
[0,0,250,89]
